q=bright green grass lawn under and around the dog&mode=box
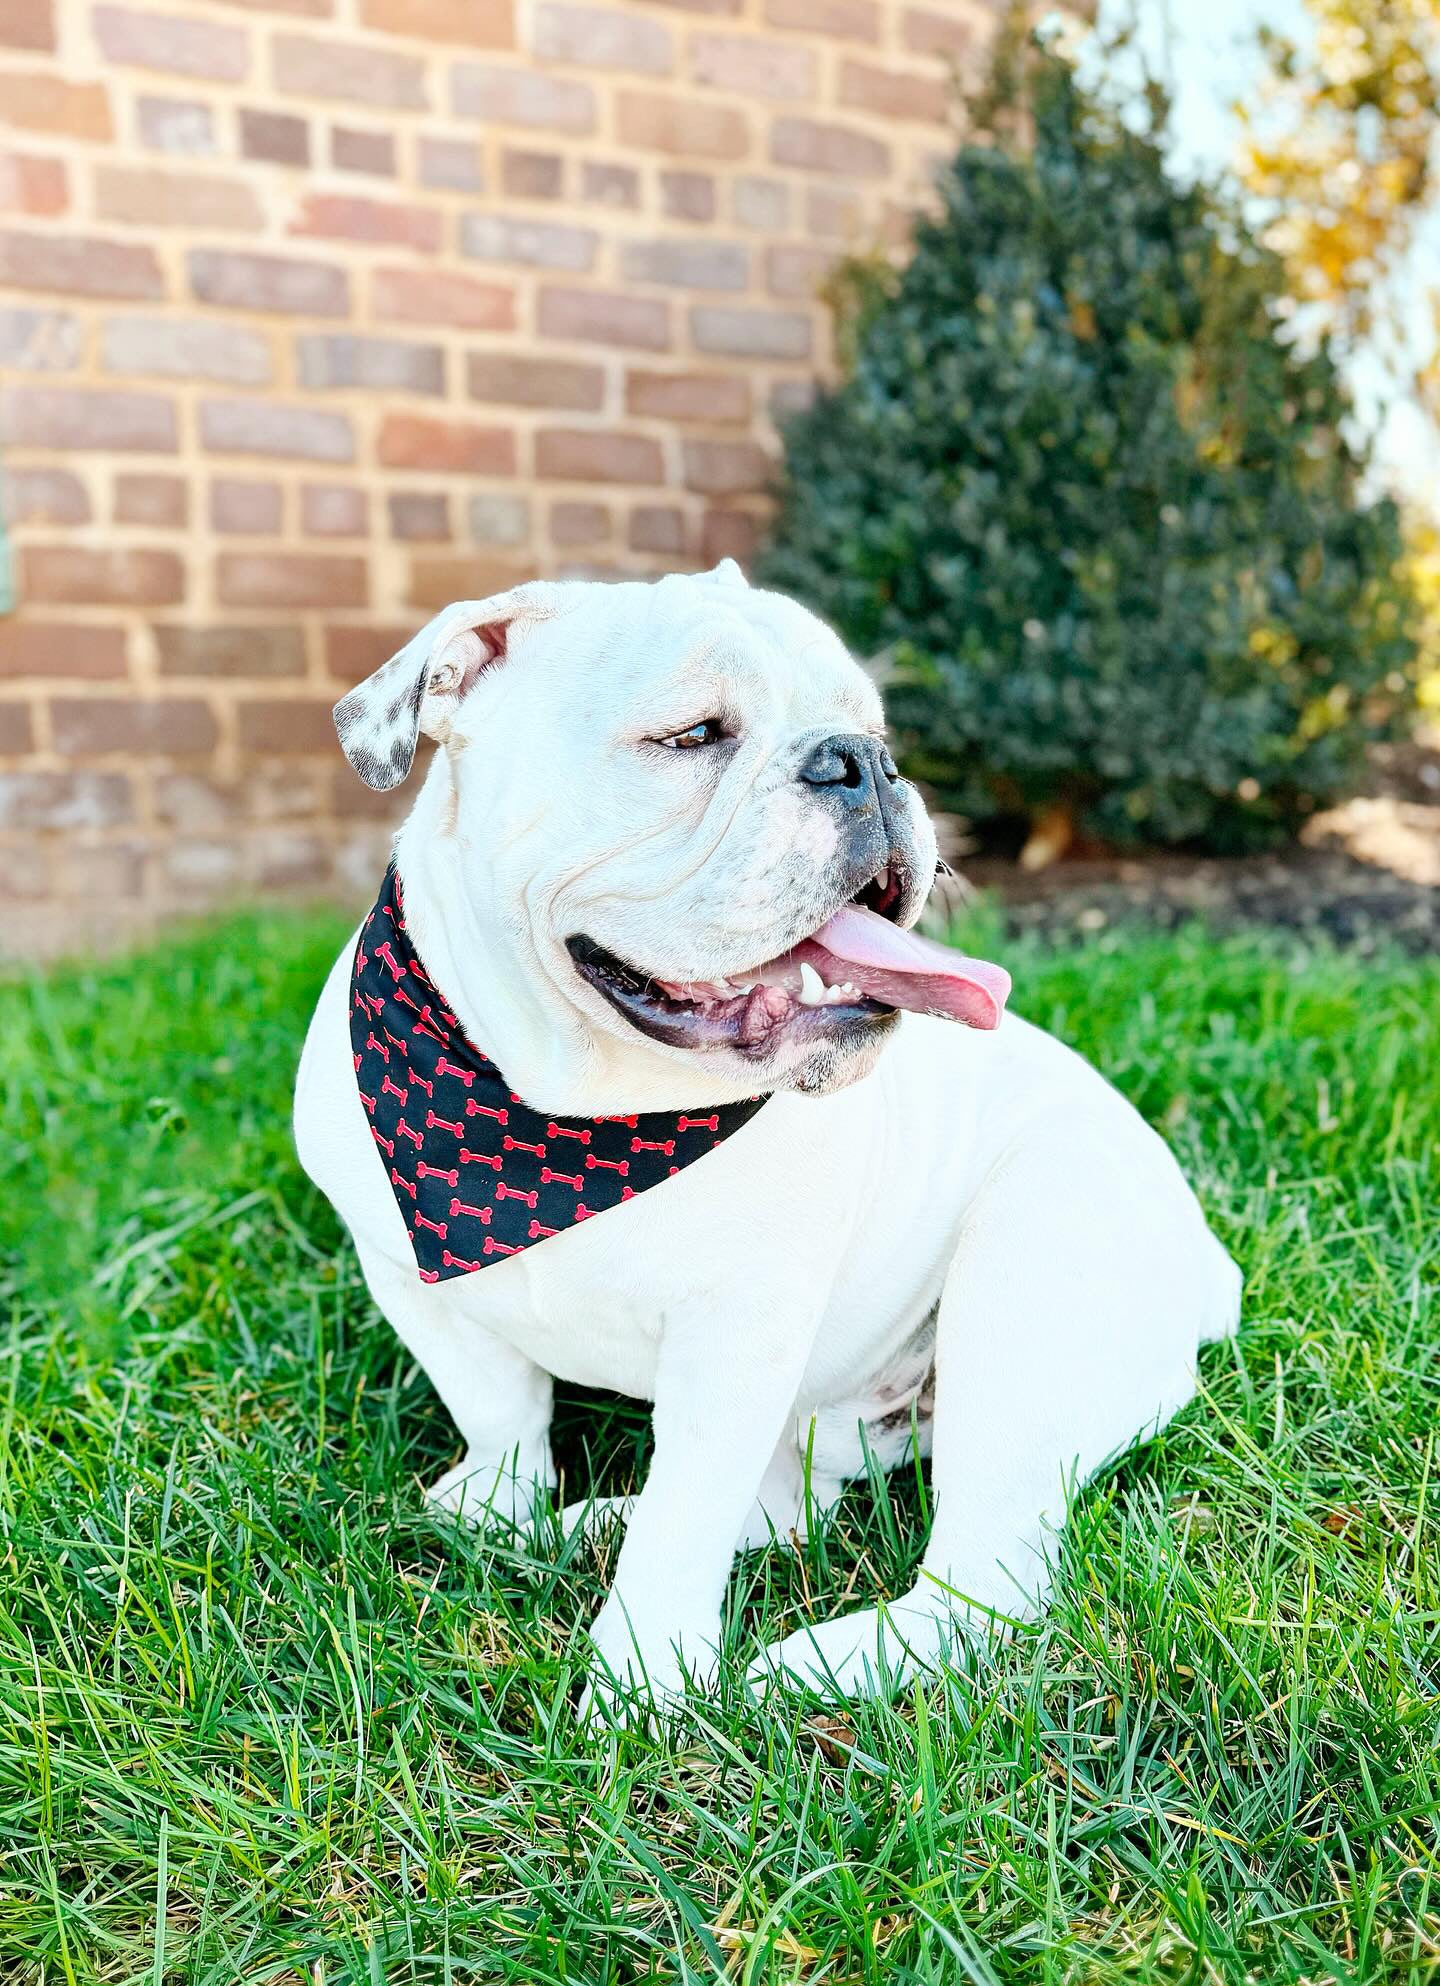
[0,918,1440,1986]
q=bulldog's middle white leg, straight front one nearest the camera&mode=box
[584,1303,818,1710]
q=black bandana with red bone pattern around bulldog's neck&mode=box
[350,868,765,1283]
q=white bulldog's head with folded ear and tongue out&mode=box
[336,560,1007,1110]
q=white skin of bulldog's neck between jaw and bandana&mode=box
[395,770,765,1116]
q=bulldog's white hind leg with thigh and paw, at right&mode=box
[753,1140,1239,1694]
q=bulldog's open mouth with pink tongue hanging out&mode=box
[568,878,1011,1059]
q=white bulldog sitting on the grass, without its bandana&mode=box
[294,560,1239,1700]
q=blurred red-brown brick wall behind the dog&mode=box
[0,0,989,951]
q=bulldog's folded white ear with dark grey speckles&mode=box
[334,580,556,792]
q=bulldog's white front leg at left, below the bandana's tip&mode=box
[360,1249,556,1523]
